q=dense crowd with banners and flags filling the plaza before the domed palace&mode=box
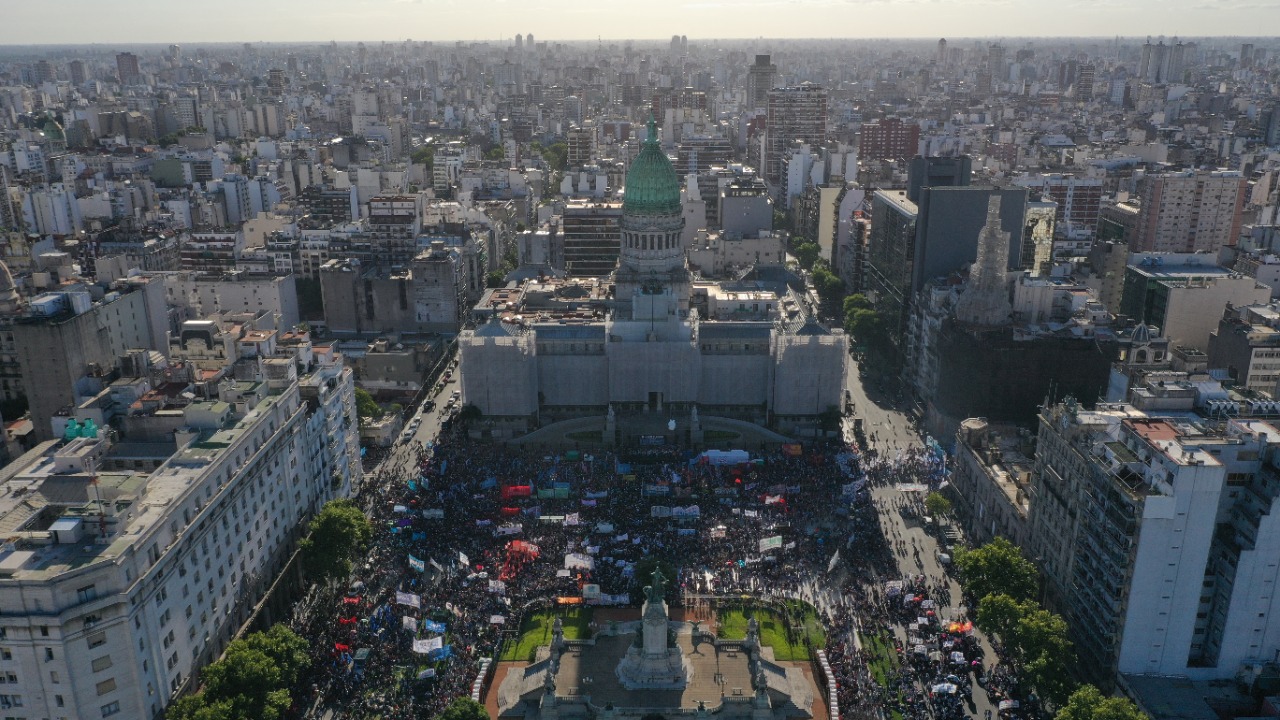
[282,409,1018,720]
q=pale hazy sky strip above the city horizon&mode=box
[0,0,1280,45]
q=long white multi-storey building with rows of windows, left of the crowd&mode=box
[0,342,360,720]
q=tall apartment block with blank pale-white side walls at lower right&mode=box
[1027,404,1280,687]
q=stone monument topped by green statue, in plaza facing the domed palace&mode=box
[616,570,692,691]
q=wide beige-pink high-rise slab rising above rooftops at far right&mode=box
[1129,170,1248,252]
